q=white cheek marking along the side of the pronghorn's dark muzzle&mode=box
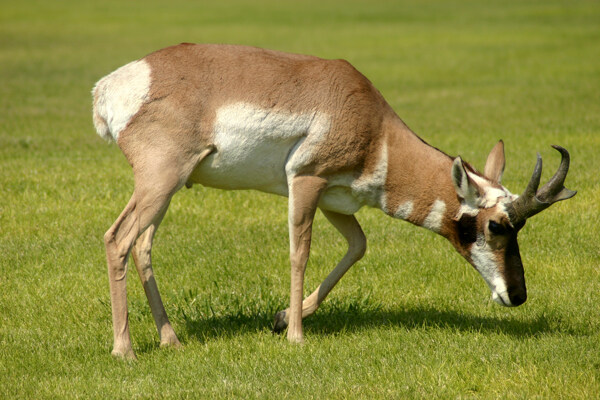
[471,234,511,306]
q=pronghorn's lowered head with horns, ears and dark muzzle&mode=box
[449,141,577,307]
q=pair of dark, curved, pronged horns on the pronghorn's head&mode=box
[508,145,577,225]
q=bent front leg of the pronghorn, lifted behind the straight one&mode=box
[273,210,367,332]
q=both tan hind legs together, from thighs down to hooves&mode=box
[104,145,215,358]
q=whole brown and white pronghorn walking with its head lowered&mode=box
[93,44,575,357]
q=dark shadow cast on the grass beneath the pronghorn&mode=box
[185,304,576,341]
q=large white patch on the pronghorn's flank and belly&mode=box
[193,103,329,196]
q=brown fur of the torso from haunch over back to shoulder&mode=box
[119,44,393,180]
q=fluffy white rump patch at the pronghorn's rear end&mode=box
[92,60,151,140]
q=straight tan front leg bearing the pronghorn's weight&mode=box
[287,176,327,343]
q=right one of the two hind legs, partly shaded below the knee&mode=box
[132,219,181,347]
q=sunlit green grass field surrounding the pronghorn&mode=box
[0,0,600,399]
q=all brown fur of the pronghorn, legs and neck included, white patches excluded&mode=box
[94,44,568,357]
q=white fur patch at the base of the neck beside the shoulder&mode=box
[351,143,388,212]
